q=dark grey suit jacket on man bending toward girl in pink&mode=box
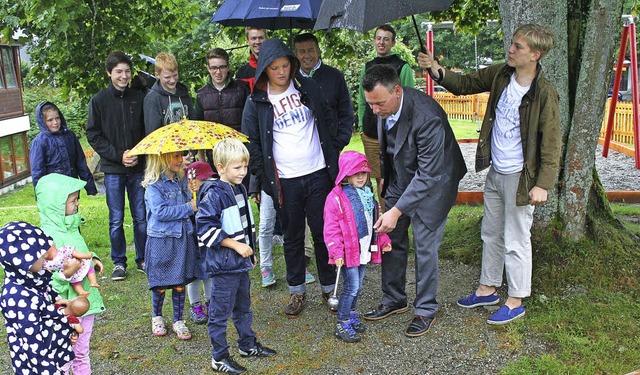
[378,87,467,230]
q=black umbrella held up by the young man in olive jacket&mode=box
[313,0,453,48]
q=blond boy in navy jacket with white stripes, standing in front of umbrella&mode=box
[196,139,276,374]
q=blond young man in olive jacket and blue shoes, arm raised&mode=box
[418,24,561,324]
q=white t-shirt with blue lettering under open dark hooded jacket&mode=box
[268,81,326,178]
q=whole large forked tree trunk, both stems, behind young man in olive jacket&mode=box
[499,0,623,240]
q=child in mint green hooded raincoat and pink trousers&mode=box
[36,173,105,374]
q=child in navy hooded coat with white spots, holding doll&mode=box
[0,222,80,375]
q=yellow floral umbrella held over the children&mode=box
[128,119,249,156]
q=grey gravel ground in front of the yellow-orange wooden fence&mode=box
[460,143,640,191]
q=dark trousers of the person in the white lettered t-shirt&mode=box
[280,169,336,294]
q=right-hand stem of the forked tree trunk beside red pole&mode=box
[558,1,622,240]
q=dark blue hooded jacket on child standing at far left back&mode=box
[29,102,98,195]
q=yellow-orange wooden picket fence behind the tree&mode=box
[433,93,633,149]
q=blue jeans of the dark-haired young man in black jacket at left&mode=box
[104,172,147,268]
